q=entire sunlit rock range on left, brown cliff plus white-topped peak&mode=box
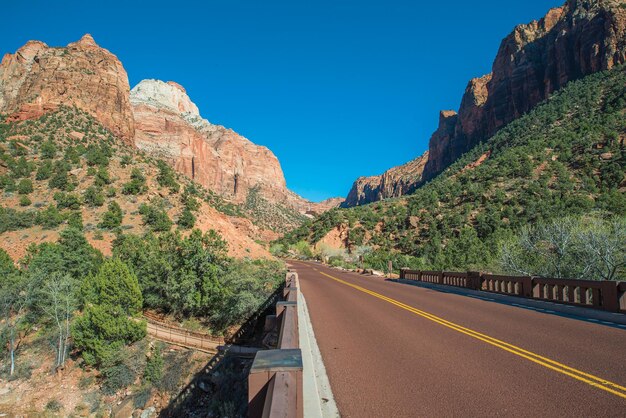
[0,35,333,238]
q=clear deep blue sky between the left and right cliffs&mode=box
[0,0,564,200]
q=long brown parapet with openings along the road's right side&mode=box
[400,269,626,313]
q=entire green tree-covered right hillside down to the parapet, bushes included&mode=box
[272,67,626,279]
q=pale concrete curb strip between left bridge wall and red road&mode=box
[298,291,340,418]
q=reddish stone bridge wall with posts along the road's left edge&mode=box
[248,272,303,418]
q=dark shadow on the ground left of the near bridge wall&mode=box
[159,287,283,418]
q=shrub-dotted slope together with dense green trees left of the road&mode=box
[0,107,284,416]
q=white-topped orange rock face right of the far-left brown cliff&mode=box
[131,80,289,202]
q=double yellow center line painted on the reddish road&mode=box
[317,270,626,399]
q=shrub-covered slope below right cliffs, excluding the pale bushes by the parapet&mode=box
[280,66,626,269]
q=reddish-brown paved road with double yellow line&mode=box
[292,262,626,417]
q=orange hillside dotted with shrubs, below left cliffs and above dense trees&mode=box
[0,106,276,259]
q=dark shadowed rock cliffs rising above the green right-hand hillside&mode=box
[346,0,626,206]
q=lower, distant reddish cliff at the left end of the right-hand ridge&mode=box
[341,151,428,207]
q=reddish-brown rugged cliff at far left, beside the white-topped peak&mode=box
[0,35,134,145]
